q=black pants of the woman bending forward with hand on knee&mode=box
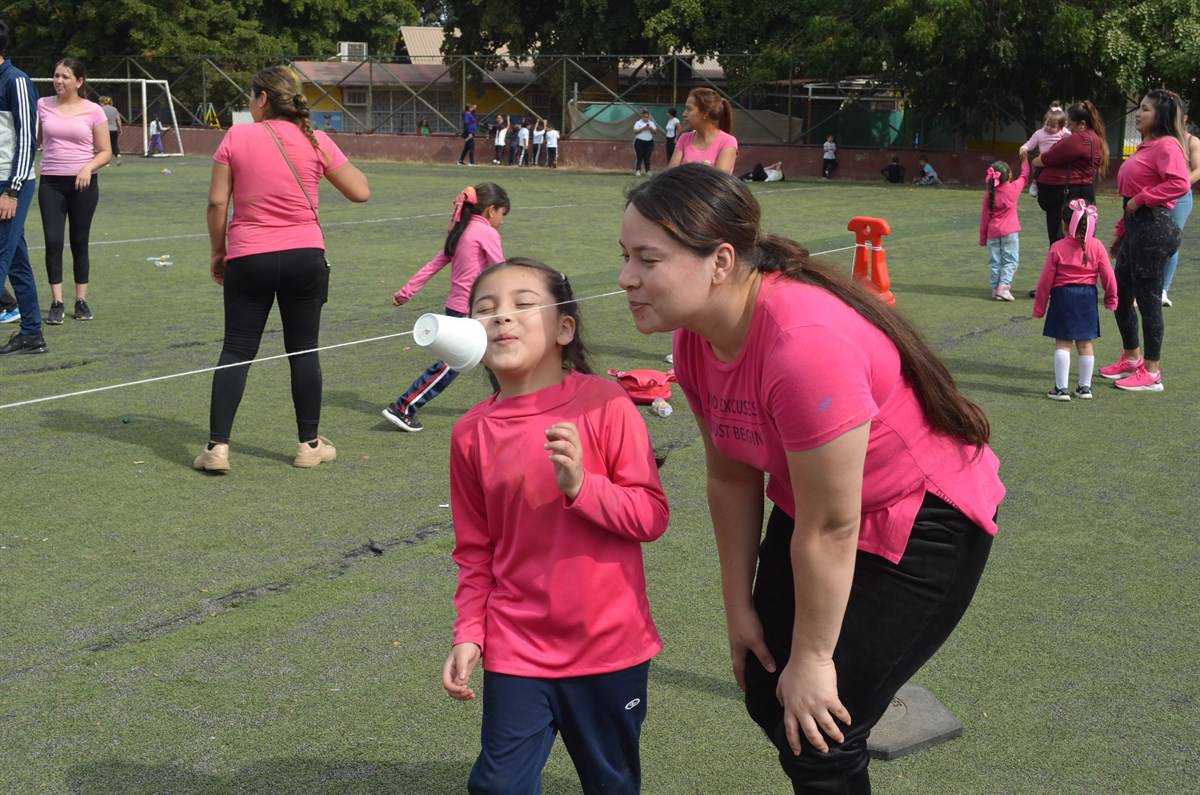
[745,495,991,795]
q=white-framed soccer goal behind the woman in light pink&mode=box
[30,77,184,157]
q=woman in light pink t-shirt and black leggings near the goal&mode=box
[37,58,113,325]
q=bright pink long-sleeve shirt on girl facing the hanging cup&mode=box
[450,372,668,679]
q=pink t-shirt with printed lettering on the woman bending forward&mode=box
[674,274,1004,563]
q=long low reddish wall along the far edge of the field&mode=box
[152,127,1142,185]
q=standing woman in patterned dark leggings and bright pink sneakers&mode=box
[1100,89,1192,391]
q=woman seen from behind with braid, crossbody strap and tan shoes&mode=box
[193,66,370,473]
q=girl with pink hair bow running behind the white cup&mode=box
[383,183,511,432]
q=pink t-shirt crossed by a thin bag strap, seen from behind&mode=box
[212,120,346,259]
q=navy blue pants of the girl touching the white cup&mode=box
[467,662,650,795]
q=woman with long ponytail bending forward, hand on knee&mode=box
[620,165,1004,793]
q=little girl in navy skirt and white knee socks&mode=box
[1033,198,1117,400]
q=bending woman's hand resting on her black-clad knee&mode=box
[775,656,850,755]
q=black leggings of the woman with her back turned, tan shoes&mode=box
[209,249,329,442]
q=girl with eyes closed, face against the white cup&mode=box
[442,258,668,793]
